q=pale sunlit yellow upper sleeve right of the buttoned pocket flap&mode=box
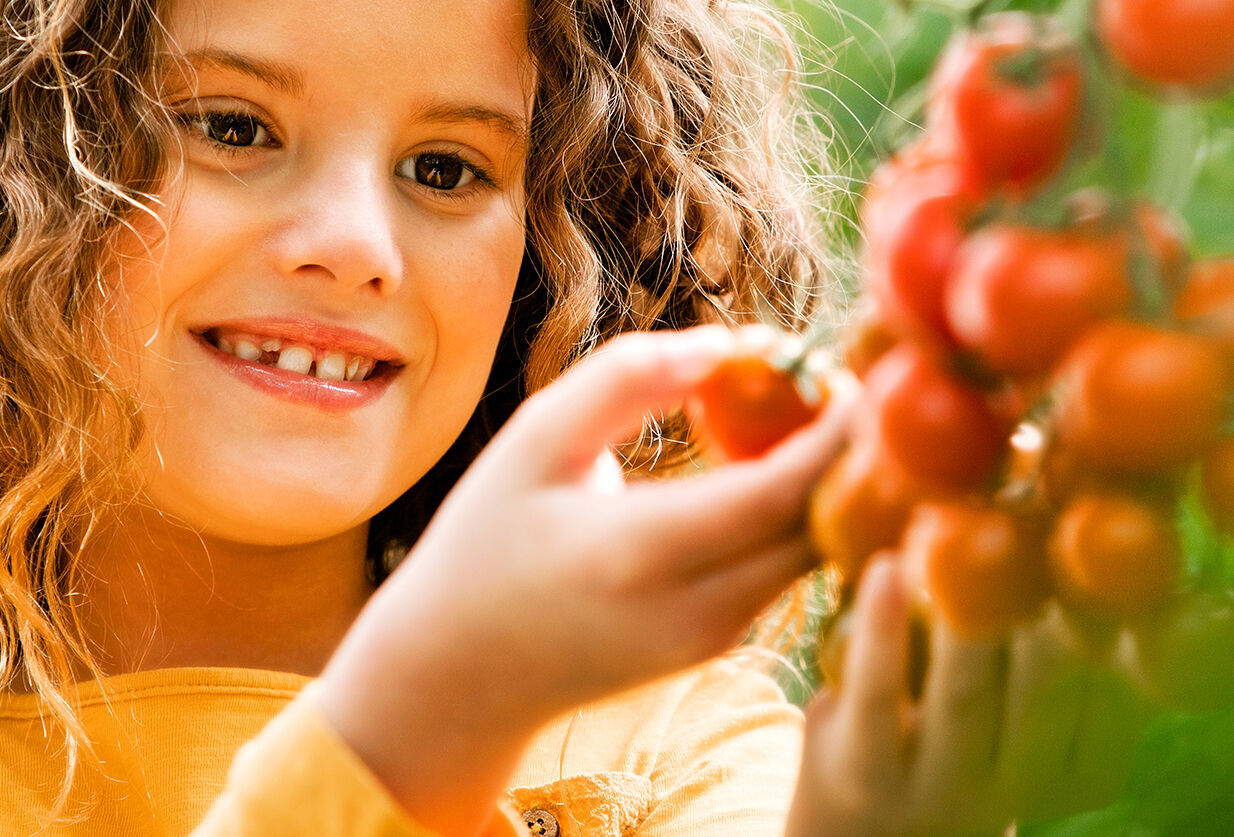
[638,660,803,837]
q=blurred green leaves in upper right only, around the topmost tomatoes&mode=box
[780,0,1234,256]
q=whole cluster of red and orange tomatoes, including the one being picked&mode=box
[701,0,1234,705]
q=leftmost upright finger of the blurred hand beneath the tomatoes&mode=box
[833,558,908,788]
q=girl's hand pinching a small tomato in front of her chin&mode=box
[322,328,845,833]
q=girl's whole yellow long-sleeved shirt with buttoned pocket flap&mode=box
[0,660,801,837]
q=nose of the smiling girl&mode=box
[274,160,405,296]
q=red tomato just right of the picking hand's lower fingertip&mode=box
[866,343,1009,489]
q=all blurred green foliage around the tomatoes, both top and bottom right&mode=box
[780,0,1234,837]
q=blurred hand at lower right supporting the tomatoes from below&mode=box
[790,560,1149,837]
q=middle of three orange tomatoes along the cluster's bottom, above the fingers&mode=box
[901,501,1050,638]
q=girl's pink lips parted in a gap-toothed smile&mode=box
[191,320,404,410]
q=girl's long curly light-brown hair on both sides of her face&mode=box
[0,0,844,819]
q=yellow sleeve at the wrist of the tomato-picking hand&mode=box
[191,684,513,837]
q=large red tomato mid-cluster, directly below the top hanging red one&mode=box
[945,223,1133,375]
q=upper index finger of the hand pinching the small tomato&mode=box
[506,326,735,481]
